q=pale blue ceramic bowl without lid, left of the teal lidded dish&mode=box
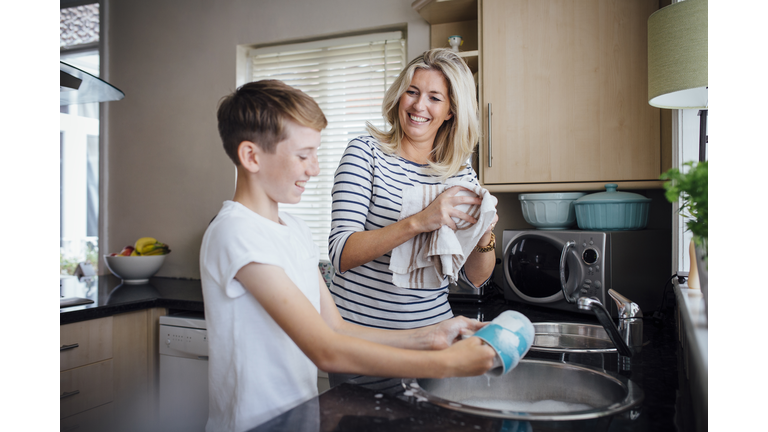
[519,192,586,230]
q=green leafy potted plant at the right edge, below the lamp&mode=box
[661,161,709,308]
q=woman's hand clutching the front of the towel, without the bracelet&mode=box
[411,186,483,232]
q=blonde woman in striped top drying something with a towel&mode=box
[328,48,498,329]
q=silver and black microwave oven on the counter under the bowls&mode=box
[497,229,672,317]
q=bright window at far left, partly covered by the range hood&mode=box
[59,3,100,274]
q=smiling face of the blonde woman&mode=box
[398,69,453,146]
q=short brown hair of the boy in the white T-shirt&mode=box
[217,80,328,166]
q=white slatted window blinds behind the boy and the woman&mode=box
[248,32,405,259]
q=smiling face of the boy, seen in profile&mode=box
[259,121,320,204]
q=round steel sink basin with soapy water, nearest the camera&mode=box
[403,359,643,421]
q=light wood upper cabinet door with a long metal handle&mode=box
[479,0,662,191]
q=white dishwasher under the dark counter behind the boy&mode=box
[159,312,208,432]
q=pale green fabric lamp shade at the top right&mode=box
[648,0,708,109]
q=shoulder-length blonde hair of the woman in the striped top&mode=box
[366,48,480,181]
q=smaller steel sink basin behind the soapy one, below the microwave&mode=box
[531,322,616,353]
